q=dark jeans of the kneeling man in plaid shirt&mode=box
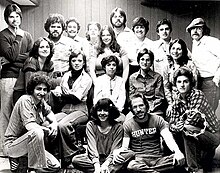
[183,131,220,171]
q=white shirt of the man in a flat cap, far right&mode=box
[192,36,220,77]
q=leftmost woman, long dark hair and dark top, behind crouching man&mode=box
[13,37,54,103]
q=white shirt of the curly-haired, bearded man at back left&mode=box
[51,36,80,72]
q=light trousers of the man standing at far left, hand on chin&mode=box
[0,78,17,149]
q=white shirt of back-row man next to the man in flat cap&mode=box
[152,39,172,75]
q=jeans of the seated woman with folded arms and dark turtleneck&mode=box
[55,111,88,158]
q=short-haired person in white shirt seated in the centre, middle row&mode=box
[93,55,126,121]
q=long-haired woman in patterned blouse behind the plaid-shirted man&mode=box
[163,39,198,118]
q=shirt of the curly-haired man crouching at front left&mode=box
[5,95,51,144]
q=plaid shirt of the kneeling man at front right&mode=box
[169,89,219,133]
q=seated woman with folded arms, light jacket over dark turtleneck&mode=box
[52,50,92,167]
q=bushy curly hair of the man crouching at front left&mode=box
[27,72,51,95]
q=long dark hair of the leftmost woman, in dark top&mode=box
[29,37,54,63]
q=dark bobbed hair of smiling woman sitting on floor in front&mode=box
[91,98,120,125]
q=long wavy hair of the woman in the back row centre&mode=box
[98,25,121,55]
